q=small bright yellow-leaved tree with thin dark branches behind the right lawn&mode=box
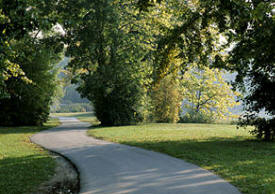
[181,65,239,120]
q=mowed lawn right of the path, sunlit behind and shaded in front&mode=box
[88,124,275,194]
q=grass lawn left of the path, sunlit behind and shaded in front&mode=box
[0,119,59,194]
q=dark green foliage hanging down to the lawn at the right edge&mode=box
[222,1,275,140]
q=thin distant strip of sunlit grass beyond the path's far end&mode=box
[51,112,99,124]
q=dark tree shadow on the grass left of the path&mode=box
[0,155,55,194]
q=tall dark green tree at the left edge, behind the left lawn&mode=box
[0,0,63,125]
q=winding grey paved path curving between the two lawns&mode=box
[31,117,239,194]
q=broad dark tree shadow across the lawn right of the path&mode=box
[120,137,275,193]
